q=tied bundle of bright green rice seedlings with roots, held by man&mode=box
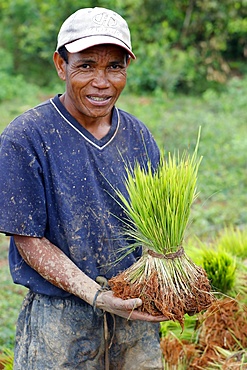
[109,134,214,326]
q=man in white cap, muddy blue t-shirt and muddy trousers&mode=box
[0,8,166,370]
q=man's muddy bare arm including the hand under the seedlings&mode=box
[14,235,166,322]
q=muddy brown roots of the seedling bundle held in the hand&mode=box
[109,255,215,327]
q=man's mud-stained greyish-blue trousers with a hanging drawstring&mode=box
[14,292,162,370]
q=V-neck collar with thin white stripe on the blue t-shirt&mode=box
[50,95,120,150]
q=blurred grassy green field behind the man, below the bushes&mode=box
[0,79,247,348]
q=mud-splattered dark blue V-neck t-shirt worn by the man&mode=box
[0,96,159,297]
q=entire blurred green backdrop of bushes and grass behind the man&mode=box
[0,0,247,366]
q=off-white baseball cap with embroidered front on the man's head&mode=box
[56,7,136,59]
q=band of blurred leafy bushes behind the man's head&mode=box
[0,0,247,100]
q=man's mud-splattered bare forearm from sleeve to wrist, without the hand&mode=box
[14,235,100,305]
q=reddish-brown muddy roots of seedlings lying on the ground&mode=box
[161,298,247,370]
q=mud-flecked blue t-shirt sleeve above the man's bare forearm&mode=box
[0,133,47,237]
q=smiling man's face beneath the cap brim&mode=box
[56,44,128,125]
